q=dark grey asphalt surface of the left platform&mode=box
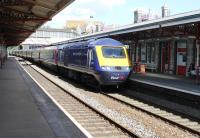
[0,58,85,138]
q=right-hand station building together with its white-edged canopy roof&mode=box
[62,10,200,76]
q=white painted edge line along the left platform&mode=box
[17,60,93,138]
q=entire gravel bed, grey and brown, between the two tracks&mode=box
[34,66,196,138]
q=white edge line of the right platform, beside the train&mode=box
[130,78,200,96]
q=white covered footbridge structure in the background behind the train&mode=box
[21,28,79,49]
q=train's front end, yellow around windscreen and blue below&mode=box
[96,46,131,85]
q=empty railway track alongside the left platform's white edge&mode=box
[21,59,140,138]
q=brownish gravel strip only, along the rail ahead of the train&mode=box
[85,93,197,138]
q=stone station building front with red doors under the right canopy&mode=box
[132,32,199,76]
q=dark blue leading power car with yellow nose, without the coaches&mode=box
[61,38,131,85]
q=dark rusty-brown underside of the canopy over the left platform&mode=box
[0,0,74,46]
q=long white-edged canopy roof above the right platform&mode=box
[62,10,200,42]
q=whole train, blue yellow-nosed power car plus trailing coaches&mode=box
[12,38,132,86]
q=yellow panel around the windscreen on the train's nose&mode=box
[96,46,130,66]
